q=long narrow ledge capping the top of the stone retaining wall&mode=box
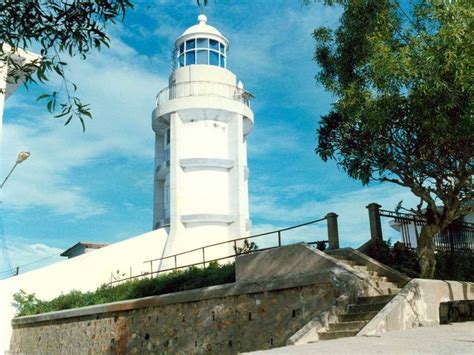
[12,271,335,327]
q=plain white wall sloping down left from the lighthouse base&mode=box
[0,229,167,354]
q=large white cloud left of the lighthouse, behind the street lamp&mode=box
[3,35,166,218]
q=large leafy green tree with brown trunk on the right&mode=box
[314,0,474,278]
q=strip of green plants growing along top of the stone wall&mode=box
[13,262,235,317]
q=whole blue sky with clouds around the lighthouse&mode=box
[0,0,414,271]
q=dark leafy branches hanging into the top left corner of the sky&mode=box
[0,0,133,129]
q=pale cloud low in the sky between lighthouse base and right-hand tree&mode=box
[250,184,417,246]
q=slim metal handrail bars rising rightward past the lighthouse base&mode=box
[109,217,328,284]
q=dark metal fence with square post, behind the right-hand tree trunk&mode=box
[367,203,474,252]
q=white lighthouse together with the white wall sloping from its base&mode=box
[0,15,253,353]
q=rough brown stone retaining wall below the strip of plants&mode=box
[10,277,341,354]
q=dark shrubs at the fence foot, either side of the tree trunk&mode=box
[367,240,474,282]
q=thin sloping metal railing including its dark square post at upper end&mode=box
[109,213,339,285]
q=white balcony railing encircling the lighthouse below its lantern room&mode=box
[156,81,254,107]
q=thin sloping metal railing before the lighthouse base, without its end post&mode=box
[109,216,331,284]
